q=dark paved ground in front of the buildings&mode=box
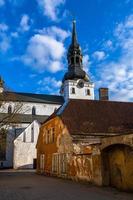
[0,171,133,200]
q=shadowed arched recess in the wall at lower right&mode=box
[102,144,133,191]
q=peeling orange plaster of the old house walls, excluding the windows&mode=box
[37,117,93,182]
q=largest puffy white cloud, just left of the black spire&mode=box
[22,27,69,73]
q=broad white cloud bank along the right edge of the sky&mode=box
[97,15,133,101]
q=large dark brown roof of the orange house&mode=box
[49,99,133,136]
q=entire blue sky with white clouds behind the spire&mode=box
[0,0,133,101]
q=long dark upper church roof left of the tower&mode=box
[0,92,64,105]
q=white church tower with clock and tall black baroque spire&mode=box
[60,21,94,101]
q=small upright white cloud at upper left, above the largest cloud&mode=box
[19,14,30,31]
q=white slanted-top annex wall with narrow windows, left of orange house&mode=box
[13,120,40,169]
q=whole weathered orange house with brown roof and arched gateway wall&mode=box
[37,100,133,191]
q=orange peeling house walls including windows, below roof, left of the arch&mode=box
[37,116,96,182]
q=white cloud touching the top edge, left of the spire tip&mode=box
[37,0,65,21]
